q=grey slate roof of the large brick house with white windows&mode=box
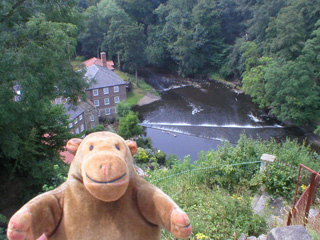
[85,64,127,90]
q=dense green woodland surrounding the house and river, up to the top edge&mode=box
[0,0,320,201]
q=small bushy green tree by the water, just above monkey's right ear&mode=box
[119,111,142,139]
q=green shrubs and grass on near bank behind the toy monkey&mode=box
[1,135,320,240]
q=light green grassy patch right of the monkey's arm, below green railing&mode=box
[153,176,268,240]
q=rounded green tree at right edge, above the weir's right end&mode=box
[265,61,320,124]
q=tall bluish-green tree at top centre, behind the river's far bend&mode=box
[148,0,223,75]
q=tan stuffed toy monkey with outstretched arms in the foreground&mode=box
[7,132,192,240]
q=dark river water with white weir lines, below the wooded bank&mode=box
[135,71,304,161]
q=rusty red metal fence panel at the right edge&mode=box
[287,164,320,235]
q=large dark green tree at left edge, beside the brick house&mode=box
[0,0,87,198]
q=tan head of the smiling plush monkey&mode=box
[67,132,137,202]
